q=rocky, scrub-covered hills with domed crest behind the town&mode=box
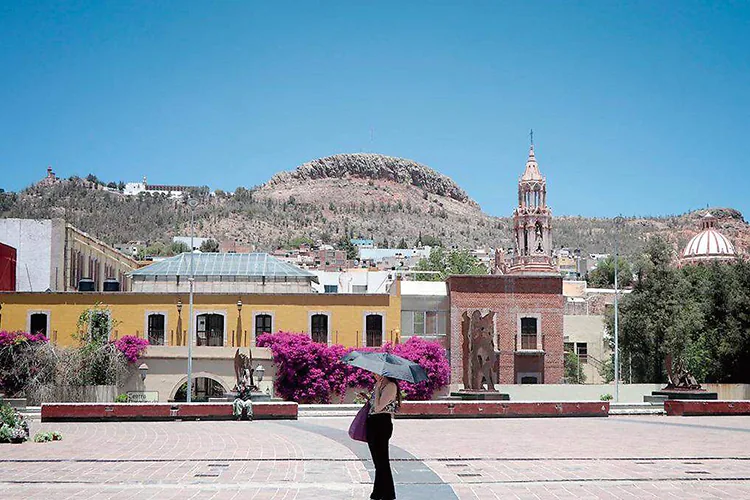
[0,154,750,254]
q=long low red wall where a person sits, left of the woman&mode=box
[42,402,297,422]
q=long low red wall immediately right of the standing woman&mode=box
[396,401,609,418]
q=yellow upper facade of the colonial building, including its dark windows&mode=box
[0,290,401,347]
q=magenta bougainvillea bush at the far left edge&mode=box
[0,331,47,396]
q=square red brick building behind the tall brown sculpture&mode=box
[448,274,565,384]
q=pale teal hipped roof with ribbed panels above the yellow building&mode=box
[129,253,318,283]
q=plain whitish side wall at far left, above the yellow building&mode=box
[0,219,54,292]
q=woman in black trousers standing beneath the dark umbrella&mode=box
[367,374,401,500]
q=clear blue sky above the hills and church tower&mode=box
[0,0,750,219]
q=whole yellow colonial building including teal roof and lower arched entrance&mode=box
[0,254,401,401]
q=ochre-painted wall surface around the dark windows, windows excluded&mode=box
[0,287,401,347]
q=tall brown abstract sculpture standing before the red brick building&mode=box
[461,310,497,392]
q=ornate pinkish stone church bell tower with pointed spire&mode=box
[508,140,557,273]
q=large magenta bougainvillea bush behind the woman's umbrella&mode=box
[257,332,450,403]
